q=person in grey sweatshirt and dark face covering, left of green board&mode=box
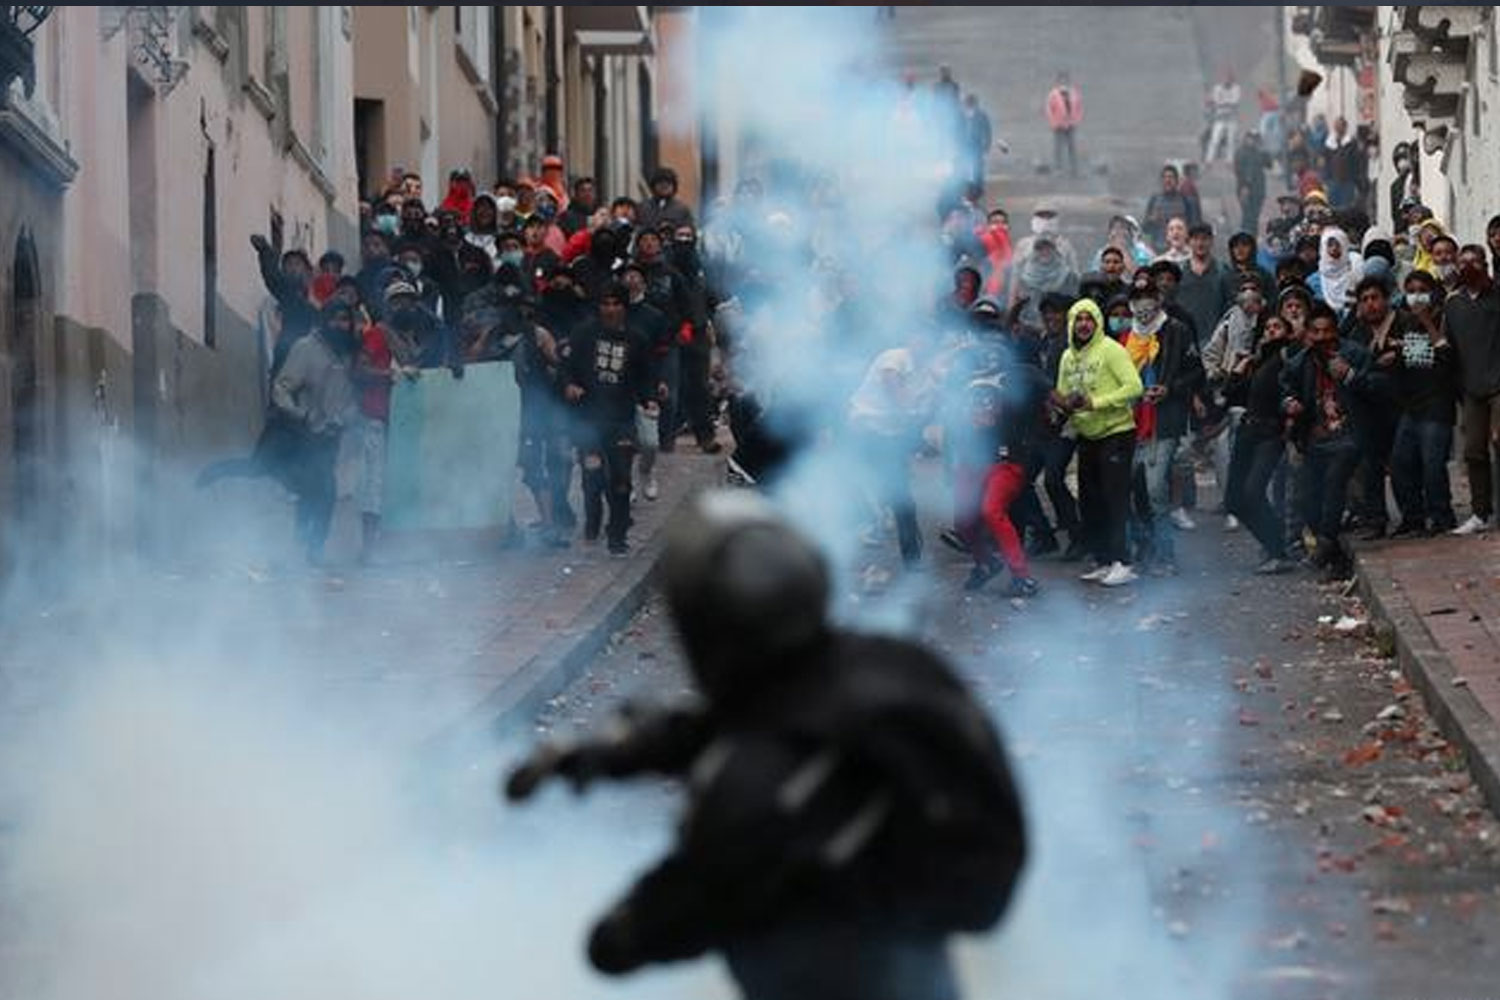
[272,301,359,565]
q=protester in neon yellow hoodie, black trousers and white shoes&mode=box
[1053,298,1145,586]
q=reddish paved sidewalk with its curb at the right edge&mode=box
[1356,534,1500,808]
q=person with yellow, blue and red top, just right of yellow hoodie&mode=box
[1122,274,1203,576]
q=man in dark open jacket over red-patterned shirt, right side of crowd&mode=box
[1281,301,1370,579]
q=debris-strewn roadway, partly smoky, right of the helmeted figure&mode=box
[540,497,1500,1000]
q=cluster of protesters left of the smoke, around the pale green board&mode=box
[211,156,722,562]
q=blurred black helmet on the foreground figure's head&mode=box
[657,490,830,702]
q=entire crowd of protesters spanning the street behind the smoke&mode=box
[222,68,1500,597]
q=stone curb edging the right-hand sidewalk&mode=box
[1355,553,1500,811]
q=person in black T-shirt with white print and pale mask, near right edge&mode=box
[1391,271,1458,538]
